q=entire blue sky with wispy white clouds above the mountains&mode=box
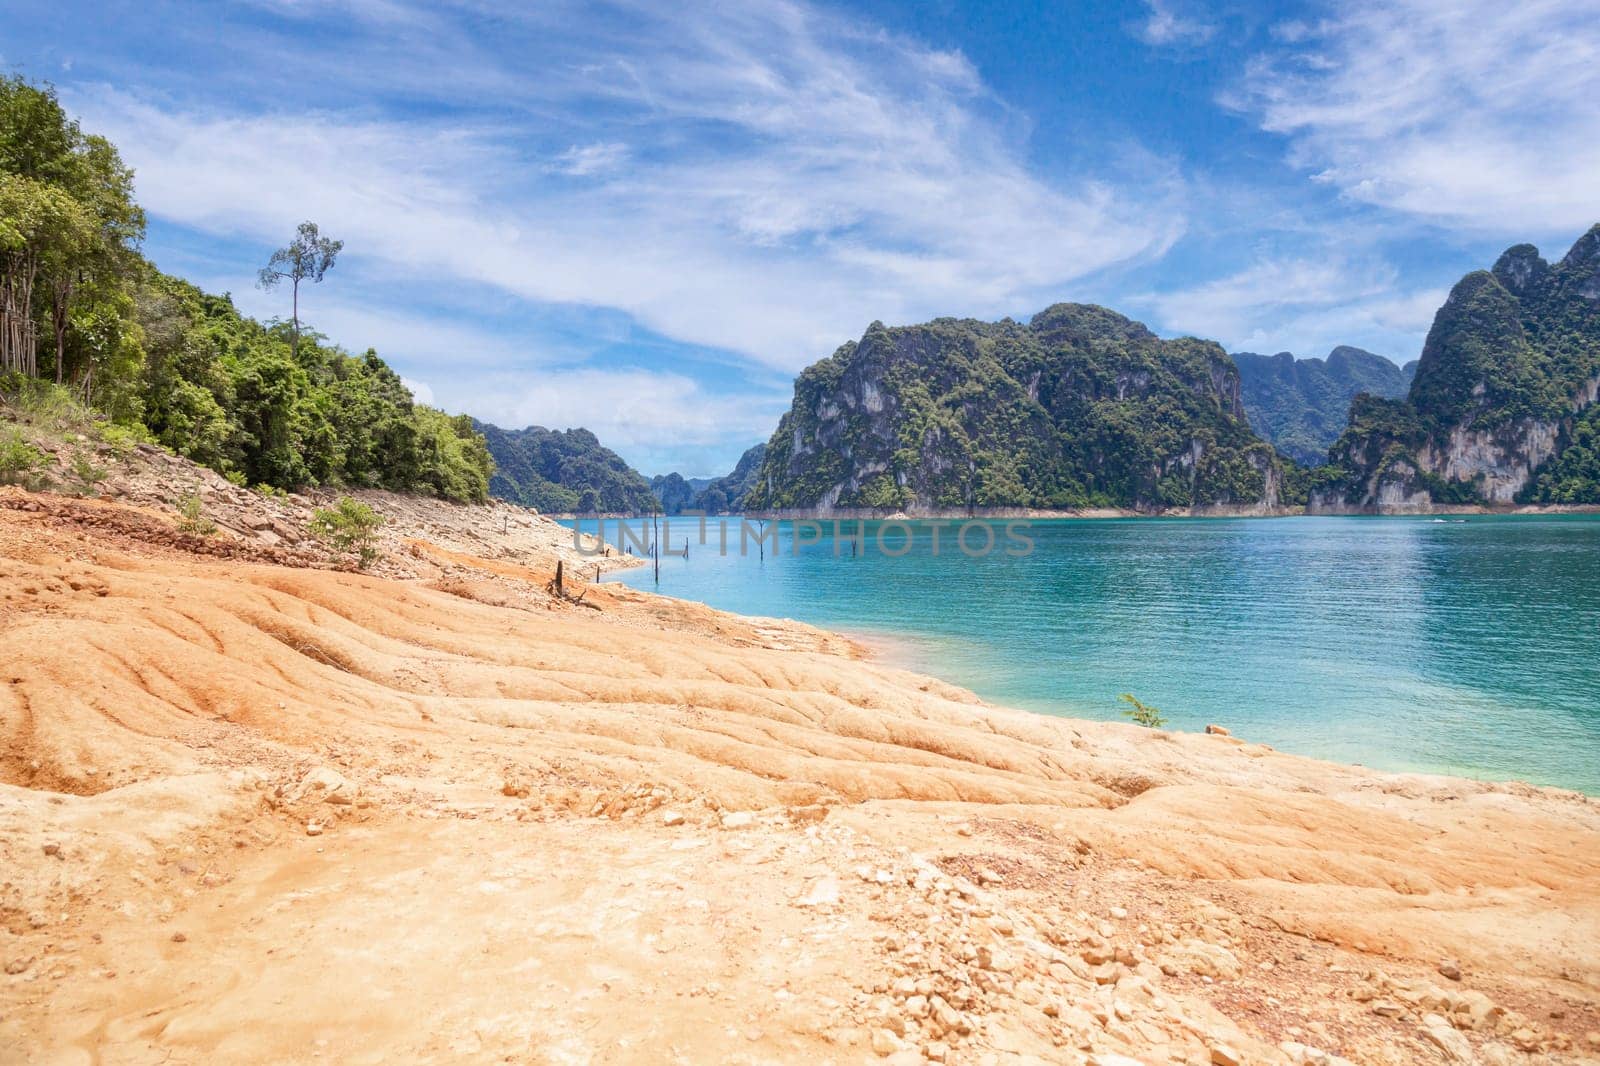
[0,0,1600,475]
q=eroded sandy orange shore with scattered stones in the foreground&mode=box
[0,490,1600,1066]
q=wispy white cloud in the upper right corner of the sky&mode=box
[1226,0,1600,235]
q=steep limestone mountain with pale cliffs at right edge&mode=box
[1310,226,1600,512]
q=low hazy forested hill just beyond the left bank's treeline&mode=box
[475,423,661,514]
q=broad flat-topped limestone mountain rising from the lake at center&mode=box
[746,304,1282,514]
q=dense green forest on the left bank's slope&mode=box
[0,77,493,501]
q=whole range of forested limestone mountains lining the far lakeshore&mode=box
[477,226,1600,514]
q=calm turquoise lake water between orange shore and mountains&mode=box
[566,515,1600,794]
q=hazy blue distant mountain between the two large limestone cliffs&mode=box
[1234,344,1416,466]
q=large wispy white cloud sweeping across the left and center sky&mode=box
[70,2,1184,371]
